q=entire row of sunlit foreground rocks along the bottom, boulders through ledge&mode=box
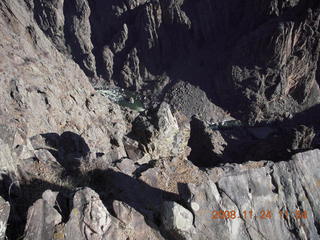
[1,150,320,239]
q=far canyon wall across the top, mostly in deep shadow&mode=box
[29,0,319,121]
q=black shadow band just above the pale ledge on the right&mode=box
[189,113,320,168]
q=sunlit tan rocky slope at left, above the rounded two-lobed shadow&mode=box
[0,1,126,171]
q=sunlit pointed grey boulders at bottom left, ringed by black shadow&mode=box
[24,188,163,240]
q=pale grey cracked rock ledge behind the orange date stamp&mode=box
[179,150,320,239]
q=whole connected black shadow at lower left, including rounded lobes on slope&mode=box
[0,126,182,239]
